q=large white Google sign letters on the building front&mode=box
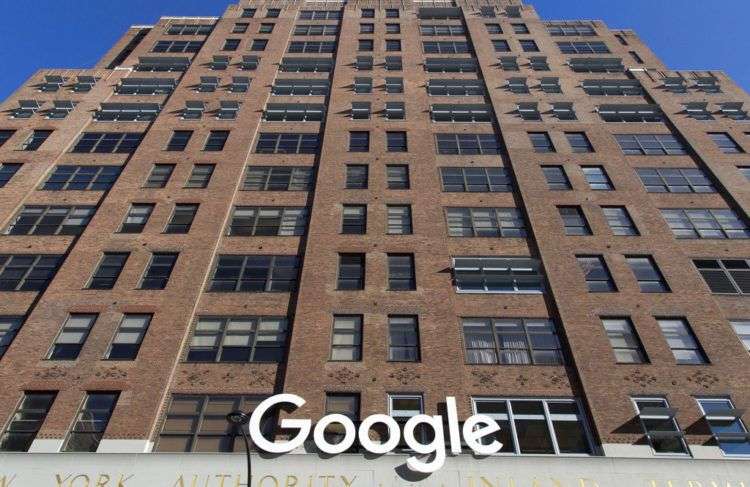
[249,394,503,473]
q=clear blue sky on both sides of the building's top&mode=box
[0,0,750,100]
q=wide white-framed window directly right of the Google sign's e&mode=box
[472,398,592,455]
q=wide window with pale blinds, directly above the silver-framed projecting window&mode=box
[445,208,526,238]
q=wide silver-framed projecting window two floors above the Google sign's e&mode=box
[453,257,544,294]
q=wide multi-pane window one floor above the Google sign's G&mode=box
[186,316,289,363]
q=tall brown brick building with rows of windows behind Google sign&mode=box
[0,0,750,486]
